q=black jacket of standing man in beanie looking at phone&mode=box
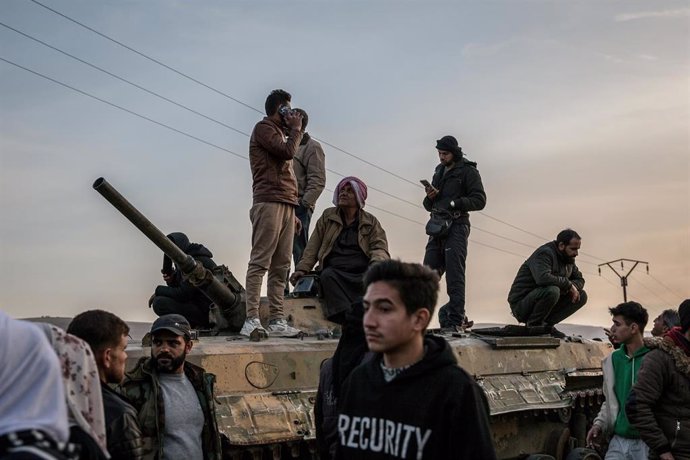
[424,158,486,224]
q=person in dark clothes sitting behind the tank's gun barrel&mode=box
[149,232,216,329]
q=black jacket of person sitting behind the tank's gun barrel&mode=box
[155,232,216,307]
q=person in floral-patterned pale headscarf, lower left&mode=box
[40,323,110,460]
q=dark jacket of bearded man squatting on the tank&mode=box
[508,241,585,305]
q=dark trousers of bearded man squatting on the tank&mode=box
[510,286,587,326]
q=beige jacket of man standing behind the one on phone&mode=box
[292,134,326,211]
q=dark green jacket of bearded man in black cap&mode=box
[118,358,221,460]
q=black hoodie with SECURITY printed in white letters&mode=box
[336,336,496,460]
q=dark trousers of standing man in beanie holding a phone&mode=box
[424,222,470,327]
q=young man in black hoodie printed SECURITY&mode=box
[335,260,496,460]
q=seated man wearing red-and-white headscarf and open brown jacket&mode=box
[290,176,390,324]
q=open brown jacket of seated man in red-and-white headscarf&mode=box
[295,208,390,272]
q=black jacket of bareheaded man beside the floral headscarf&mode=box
[101,384,144,460]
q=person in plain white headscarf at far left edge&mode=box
[0,311,69,459]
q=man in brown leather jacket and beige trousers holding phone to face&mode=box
[240,89,302,337]
